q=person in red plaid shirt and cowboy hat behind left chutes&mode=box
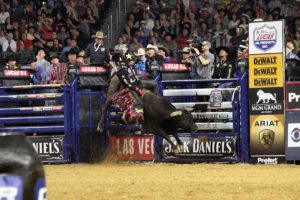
[49,53,66,84]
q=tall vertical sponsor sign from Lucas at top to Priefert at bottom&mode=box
[249,20,285,164]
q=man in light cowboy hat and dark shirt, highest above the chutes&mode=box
[85,31,109,64]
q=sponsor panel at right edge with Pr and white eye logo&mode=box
[285,82,300,160]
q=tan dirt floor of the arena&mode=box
[45,163,300,200]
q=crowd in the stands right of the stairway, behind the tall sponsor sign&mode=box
[115,0,300,68]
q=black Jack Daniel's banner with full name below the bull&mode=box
[163,135,237,159]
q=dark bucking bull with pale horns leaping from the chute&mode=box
[97,76,198,148]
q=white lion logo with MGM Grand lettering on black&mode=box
[251,90,282,112]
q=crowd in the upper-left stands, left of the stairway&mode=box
[0,0,111,62]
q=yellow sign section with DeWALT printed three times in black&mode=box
[249,54,284,88]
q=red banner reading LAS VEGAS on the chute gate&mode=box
[109,135,154,161]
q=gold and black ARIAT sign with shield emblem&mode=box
[250,114,284,156]
